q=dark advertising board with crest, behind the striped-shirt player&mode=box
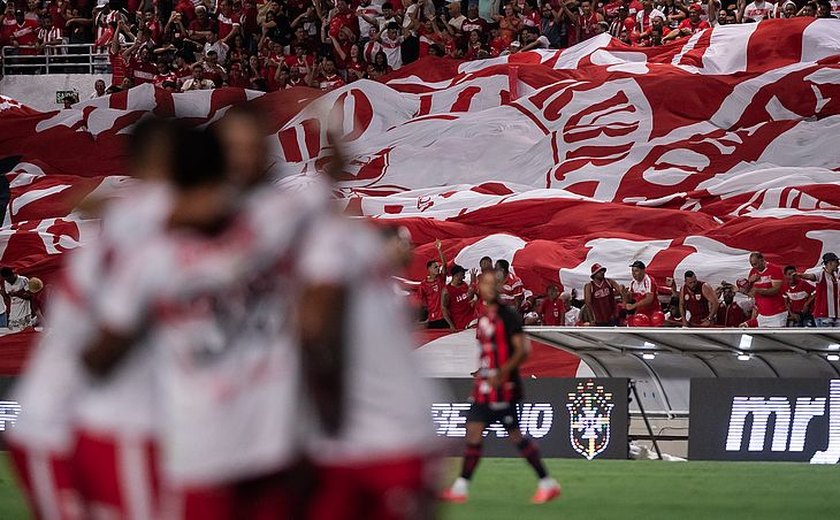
[432,378,628,460]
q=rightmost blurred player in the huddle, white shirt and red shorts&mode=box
[297,157,436,520]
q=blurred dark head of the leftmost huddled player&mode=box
[128,117,178,180]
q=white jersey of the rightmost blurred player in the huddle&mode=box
[298,214,435,465]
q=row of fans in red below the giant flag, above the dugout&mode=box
[416,248,840,331]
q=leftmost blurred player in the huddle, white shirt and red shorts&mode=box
[8,119,179,518]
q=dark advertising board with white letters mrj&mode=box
[688,378,840,464]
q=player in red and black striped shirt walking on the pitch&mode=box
[441,273,560,504]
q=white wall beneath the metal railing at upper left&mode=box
[0,74,111,111]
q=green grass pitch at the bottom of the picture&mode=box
[0,459,840,520]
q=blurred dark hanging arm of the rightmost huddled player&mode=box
[298,283,347,434]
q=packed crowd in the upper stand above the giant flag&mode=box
[0,0,840,91]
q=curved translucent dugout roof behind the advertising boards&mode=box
[525,327,840,416]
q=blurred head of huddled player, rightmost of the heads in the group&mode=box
[215,105,268,189]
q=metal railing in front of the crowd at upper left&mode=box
[0,43,111,76]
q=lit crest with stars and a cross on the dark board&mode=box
[566,381,615,460]
